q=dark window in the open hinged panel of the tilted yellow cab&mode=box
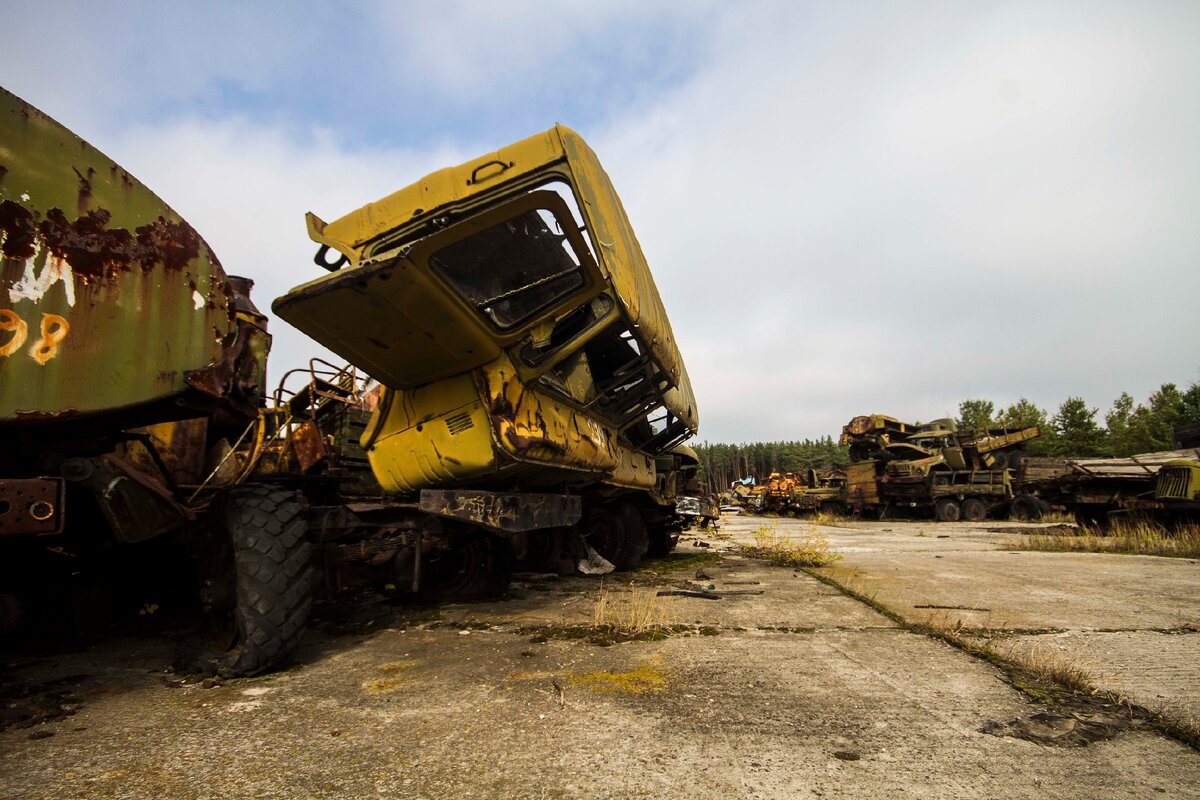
[430,209,586,330]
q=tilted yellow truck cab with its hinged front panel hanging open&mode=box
[272,126,698,566]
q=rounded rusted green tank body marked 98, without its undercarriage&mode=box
[0,90,268,429]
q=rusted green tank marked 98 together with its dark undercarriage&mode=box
[0,89,273,657]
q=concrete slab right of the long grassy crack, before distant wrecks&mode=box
[724,517,1200,743]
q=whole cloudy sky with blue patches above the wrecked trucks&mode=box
[0,0,1200,441]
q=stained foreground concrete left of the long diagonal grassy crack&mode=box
[0,523,1200,800]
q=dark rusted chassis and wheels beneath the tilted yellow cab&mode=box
[308,489,683,599]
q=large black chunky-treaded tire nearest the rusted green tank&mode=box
[198,485,313,676]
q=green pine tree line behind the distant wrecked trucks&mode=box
[691,383,1200,492]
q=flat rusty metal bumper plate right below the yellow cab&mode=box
[420,489,583,534]
